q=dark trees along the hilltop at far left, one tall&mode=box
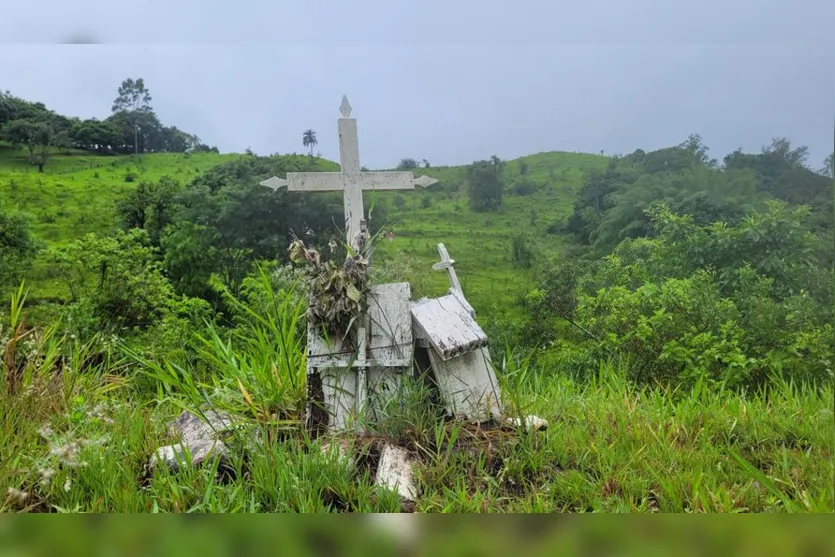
[0,78,217,172]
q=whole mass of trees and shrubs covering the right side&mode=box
[519,132,835,389]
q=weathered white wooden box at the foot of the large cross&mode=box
[308,282,414,431]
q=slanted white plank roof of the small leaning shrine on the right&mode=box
[412,294,488,361]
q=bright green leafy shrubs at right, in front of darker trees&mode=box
[528,203,835,387]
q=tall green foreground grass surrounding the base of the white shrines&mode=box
[0,284,835,512]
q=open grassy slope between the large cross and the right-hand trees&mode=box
[372,152,607,314]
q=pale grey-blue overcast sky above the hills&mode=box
[0,0,835,168]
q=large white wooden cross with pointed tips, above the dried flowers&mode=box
[261,95,437,248]
